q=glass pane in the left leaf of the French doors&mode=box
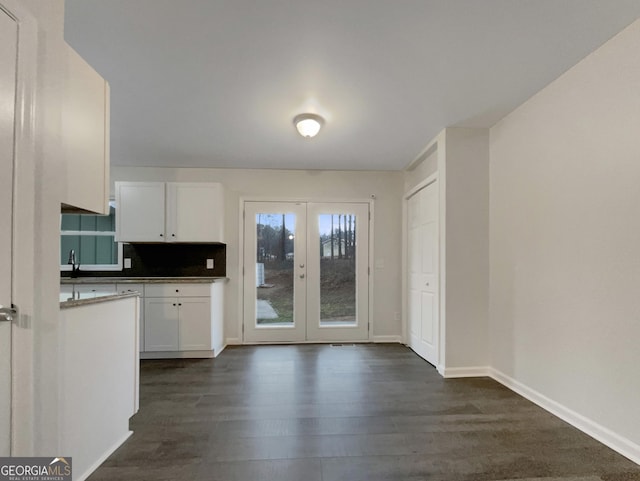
[256,213,296,327]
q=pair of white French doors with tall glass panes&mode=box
[243,202,369,342]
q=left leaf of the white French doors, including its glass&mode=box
[243,202,307,342]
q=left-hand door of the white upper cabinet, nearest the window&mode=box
[116,182,166,242]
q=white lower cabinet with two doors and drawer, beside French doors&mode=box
[144,283,213,357]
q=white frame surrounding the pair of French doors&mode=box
[238,197,375,344]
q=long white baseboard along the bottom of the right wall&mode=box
[489,368,640,464]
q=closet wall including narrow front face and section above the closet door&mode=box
[404,128,489,377]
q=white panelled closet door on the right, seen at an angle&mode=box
[407,180,440,366]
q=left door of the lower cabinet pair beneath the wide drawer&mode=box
[144,297,179,351]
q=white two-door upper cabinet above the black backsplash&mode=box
[116,182,224,242]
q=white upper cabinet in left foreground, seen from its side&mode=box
[62,45,110,215]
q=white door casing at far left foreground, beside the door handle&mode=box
[0,0,38,455]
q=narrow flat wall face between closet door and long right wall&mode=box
[444,128,489,368]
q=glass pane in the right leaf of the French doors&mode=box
[318,213,356,326]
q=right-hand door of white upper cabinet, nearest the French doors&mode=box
[167,182,223,242]
